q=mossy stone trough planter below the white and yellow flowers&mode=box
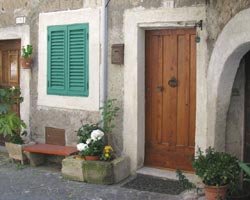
[62,156,130,185]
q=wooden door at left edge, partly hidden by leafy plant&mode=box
[0,40,21,145]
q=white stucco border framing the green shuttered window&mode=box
[38,9,100,111]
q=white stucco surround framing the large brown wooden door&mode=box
[123,7,207,172]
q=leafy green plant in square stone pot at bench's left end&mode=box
[0,87,27,163]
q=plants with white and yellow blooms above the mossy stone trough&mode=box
[77,99,119,161]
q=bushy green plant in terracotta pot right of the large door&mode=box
[192,147,240,200]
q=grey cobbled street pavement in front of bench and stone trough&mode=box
[0,153,186,200]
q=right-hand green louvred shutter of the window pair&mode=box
[68,24,89,96]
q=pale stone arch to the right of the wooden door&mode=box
[207,9,250,151]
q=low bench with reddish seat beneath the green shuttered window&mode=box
[23,144,77,166]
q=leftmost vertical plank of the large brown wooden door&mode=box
[146,34,162,143]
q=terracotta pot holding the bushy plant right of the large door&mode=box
[204,185,227,200]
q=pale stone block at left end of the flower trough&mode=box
[62,156,84,181]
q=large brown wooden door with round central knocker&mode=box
[145,29,196,171]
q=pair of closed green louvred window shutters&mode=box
[47,24,89,96]
